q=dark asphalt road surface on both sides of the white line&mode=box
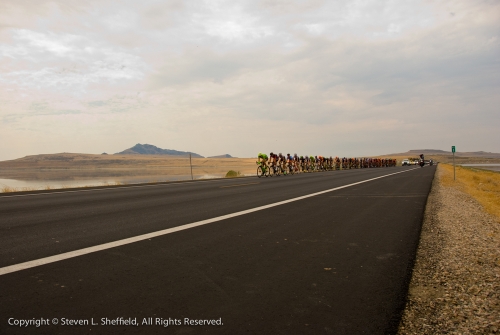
[0,167,435,334]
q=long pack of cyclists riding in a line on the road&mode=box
[257,152,396,177]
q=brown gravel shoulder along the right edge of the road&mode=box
[398,167,500,334]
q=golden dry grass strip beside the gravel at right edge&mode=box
[438,164,500,220]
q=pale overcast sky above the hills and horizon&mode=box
[0,0,500,160]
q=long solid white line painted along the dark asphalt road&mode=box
[0,168,416,276]
